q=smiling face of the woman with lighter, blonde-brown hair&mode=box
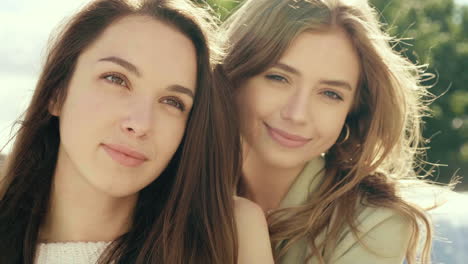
[237,29,360,168]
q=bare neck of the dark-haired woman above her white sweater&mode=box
[39,155,137,242]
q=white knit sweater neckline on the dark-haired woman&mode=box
[35,242,110,264]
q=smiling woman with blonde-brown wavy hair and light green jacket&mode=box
[216,0,431,264]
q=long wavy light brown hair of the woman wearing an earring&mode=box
[217,0,432,264]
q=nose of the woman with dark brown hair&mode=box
[120,100,153,138]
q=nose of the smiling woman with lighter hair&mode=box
[280,89,310,124]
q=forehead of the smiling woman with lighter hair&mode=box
[280,29,361,86]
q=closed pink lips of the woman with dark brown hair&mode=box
[102,144,148,167]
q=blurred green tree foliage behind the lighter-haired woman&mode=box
[204,0,468,191]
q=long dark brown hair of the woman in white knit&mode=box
[0,0,240,264]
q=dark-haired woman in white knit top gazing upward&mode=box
[0,0,271,264]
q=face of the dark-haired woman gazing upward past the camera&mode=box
[51,16,197,197]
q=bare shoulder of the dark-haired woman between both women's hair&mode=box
[234,196,273,264]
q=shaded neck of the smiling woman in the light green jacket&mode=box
[242,153,305,213]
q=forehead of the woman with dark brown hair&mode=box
[80,16,197,91]
